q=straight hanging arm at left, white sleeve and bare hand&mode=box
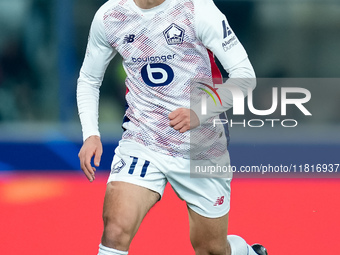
[77,8,116,182]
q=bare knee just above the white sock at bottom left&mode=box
[102,215,132,250]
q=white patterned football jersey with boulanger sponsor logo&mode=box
[78,0,252,159]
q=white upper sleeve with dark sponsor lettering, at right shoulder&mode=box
[195,0,248,72]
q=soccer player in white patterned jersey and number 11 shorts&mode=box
[77,0,267,255]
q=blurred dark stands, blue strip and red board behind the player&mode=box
[0,0,340,255]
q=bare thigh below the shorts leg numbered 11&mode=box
[103,181,160,238]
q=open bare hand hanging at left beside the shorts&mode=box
[78,136,103,182]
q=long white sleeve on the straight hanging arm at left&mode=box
[77,9,117,141]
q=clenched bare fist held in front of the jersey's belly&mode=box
[169,108,200,133]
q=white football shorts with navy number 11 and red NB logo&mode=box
[108,140,231,218]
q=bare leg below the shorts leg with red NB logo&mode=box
[188,207,229,254]
